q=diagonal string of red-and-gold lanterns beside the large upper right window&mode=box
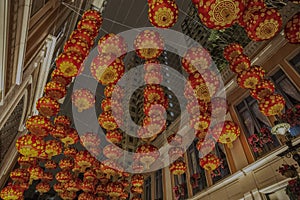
[224,44,285,116]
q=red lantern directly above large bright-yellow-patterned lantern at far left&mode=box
[26,115,53,137]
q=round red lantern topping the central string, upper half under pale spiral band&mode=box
[134,30,165,60]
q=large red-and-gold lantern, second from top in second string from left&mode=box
[90,53,125,85]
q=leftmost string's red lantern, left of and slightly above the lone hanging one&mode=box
[44,81,67,100]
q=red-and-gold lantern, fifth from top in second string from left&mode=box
[98,111,122,131]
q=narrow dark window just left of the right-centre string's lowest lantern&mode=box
[188,141,207,195]
